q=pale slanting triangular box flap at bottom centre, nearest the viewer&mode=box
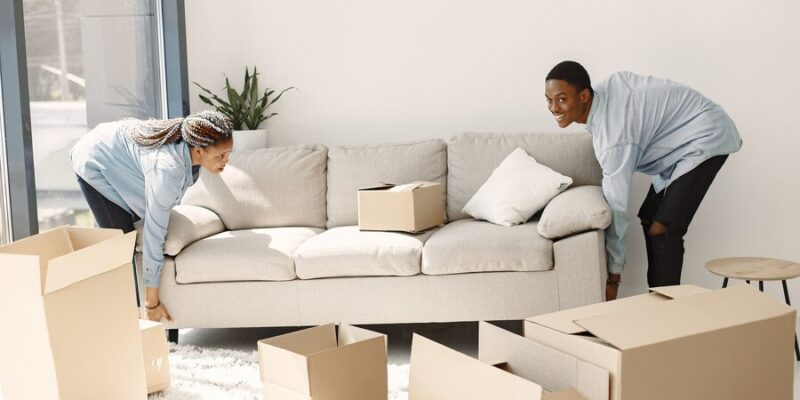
[408,334,542,400]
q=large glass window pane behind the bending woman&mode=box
[23,0,162,230]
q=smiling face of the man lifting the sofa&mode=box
[544,79,591,128]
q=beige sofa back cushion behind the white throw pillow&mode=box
[447,133,603,221]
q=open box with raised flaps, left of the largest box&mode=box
[408,323,608,400]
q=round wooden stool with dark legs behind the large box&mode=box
[706,257,800,361]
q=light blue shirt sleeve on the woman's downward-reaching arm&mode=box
[142,168,183,287]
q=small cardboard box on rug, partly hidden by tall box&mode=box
[139,319,170,394]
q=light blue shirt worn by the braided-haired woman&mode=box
[70,122,194,287]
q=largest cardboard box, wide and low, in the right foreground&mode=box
[525,285,796,400]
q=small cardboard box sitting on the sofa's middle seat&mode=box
[358,182,444,232]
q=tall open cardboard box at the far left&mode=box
[0,227,147,400]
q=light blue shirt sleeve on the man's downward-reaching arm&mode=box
[599,144,638,274]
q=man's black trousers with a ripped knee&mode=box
[639,154,728,287]
